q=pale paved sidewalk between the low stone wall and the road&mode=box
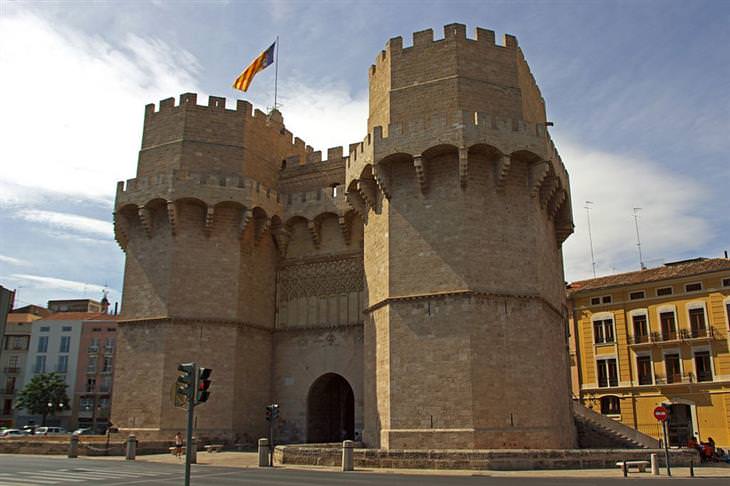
[94,452,730,479]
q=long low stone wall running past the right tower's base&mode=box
[274,445,700,471]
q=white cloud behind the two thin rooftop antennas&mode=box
[559,137,713,280]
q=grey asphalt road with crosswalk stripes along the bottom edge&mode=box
[0,455,728,486]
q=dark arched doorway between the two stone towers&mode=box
[307,373,355,443]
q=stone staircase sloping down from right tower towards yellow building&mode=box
[573,402,659,449]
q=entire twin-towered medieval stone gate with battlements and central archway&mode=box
[112,24,575,448]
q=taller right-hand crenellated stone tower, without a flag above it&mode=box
[347,24,574,448]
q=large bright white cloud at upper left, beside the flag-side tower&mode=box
[0,10,198,203]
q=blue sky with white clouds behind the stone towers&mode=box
[0,0,730,304]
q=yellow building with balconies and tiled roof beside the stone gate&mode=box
[568,258,730,448]
